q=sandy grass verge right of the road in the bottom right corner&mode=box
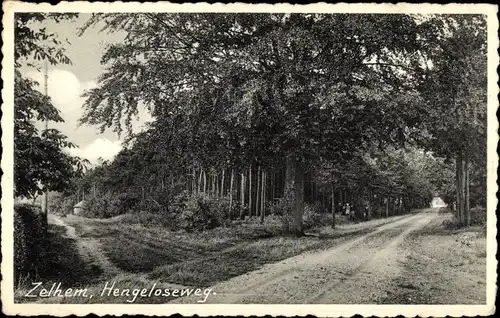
[383,214,486,304]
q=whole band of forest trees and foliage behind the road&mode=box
[15,13,487,236]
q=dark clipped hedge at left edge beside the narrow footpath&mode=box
[14,203,47,281]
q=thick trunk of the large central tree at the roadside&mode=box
[285,157,304,236]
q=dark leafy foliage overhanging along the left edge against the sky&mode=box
[14,13,86,197]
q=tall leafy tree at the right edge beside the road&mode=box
[422,15,487,225]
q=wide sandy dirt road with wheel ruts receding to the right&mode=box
[176,209,438,304]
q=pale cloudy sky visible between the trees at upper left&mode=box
[20,14,151,163]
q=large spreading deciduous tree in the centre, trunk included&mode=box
[82,13,446,235]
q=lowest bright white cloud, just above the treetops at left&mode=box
[68,138,122,164]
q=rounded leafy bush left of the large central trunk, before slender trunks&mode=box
[172,193,236,231]
